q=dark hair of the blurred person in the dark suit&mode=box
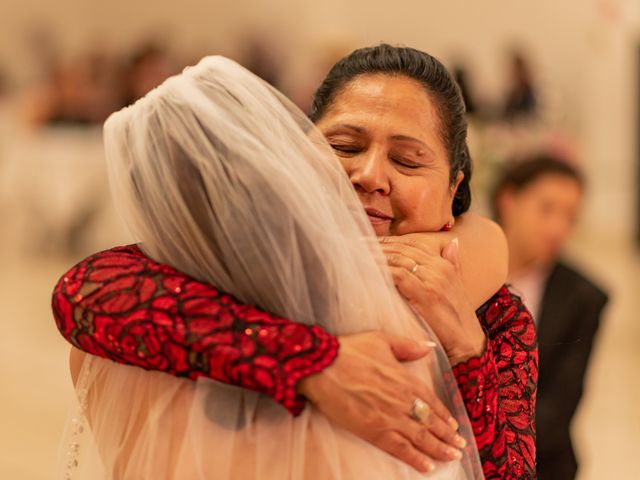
[491,153,585,221]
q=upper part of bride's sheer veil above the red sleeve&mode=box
[105,57,399,333]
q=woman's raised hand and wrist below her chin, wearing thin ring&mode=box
[381,236,486,365]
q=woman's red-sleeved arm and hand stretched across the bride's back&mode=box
[53,246,463,471]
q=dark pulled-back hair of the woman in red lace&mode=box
[310,44,472,216]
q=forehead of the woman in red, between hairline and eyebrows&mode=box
[319,74,440,136]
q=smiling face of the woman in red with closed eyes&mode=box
[316,74,464,236]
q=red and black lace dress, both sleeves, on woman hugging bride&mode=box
[53,246,538,479]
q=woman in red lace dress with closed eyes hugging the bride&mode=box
[53,45,537,478]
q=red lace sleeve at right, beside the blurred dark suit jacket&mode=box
[454,287,538,479]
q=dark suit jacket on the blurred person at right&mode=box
[536,263,607,480]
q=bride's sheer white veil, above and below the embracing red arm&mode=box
[59,57,482,480]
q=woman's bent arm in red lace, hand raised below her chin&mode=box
[384,235,538,479]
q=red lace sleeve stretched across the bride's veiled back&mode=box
[52,246,338,414]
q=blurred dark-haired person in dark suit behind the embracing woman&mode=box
[492,155,607,480]
